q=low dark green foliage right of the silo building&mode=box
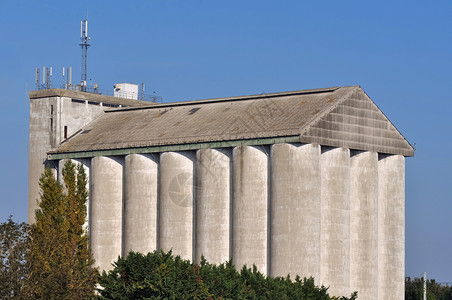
[405,277,452,300]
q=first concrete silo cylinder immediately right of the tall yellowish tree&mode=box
[90,156,123,270]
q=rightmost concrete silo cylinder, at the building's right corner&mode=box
[378,155,405,299]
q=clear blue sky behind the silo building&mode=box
[0,0,452,282]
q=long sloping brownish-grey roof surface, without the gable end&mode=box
[51,86,411,157]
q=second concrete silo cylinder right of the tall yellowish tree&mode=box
[124,154,158,254]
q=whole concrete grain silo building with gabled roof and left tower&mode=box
[29,86,414,299]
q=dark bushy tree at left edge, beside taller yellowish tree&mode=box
[0,216,30,299]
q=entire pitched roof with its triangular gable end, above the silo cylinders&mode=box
[51,86,414,156]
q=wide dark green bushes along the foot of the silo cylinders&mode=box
[99,251,356,300]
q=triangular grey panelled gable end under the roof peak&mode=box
[300,88,414,156]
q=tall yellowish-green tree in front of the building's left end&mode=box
[28,161,98,299]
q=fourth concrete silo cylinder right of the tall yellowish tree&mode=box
[196,149,231,264]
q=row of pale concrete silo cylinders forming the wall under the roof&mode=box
[38,143,405,299]
